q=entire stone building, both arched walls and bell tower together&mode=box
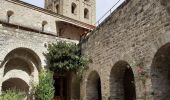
[0,0,170,100]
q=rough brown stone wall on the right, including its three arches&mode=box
[81,0,170,100]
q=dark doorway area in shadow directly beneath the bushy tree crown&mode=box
[53,72,80,100]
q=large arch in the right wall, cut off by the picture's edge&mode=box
[151,43,170,100]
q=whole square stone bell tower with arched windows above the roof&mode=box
[45,0,96,25]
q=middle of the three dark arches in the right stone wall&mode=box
[110,61,136,100]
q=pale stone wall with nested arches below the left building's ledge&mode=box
[0,23,77,93]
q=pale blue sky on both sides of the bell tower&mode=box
[22,0,124,23]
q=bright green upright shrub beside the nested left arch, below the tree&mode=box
[35,70,55,100]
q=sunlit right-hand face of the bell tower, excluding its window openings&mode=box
[63,0,96,25]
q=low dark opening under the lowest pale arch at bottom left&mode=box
[2,78,29,93]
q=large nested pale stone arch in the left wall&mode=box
[0,48,41,92]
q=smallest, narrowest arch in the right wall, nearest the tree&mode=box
[86,71,102,100]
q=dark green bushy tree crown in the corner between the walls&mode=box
[45,41,91,73]
